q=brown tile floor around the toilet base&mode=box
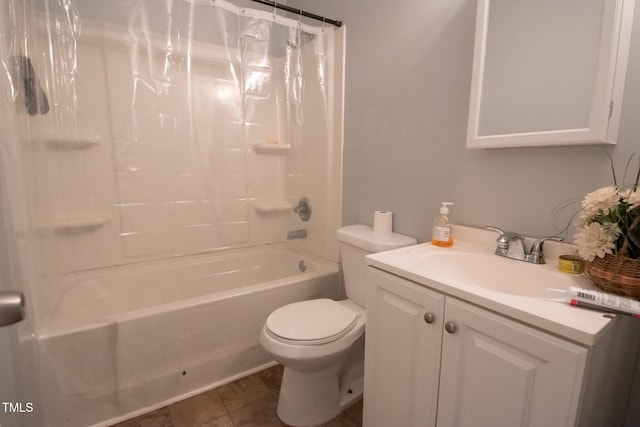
[113,365,362,427]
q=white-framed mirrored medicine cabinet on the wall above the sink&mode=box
[467,0,634,148]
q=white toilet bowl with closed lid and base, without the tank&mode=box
[260,299,365,426]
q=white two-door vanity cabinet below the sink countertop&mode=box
[364,266,637,427]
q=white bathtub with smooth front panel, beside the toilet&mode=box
[36,243,339,427]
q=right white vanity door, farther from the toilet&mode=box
[437,297,587,427]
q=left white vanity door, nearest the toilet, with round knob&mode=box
[364,267,444,427]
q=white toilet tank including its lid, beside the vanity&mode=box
[338,224,418,307]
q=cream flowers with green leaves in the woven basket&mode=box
[574,154,640,261]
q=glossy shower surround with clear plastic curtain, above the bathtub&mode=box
[0,0,344,425]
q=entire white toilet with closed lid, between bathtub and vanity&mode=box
[260,225,417,427]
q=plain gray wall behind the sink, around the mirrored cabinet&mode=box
[288,0,640,242]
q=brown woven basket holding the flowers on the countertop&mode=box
[584,255,640,299]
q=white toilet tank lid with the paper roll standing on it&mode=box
[338,224,418,252]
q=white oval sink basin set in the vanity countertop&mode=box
[419,250,592,299]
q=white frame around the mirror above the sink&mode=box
[467,0,635,148]
